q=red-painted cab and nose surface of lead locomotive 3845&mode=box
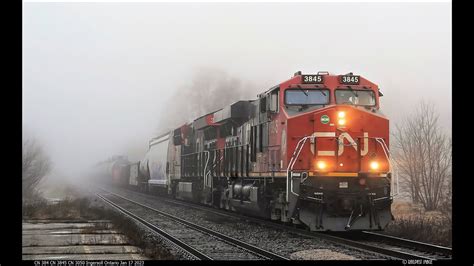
[270,75,389,175]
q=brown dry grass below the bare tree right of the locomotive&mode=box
[385,202,452,247]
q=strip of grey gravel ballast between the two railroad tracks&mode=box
[96,185,387,260]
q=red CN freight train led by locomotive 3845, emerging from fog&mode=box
[100,72,393,231]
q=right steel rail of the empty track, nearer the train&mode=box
[100,191,289,260]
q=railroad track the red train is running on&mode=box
[100,186,452,260]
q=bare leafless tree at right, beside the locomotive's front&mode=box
[392,101,452,210]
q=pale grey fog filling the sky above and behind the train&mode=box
[23,2,452,185]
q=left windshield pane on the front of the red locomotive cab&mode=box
[285,89,329,105]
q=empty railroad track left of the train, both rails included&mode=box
[96,191,288,260]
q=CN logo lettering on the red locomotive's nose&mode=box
[311,132,369,156]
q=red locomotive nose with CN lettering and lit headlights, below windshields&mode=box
[310,105,389,173]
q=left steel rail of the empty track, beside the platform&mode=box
[96,194,212,260]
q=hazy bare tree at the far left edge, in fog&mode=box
[22,138,51,199]
